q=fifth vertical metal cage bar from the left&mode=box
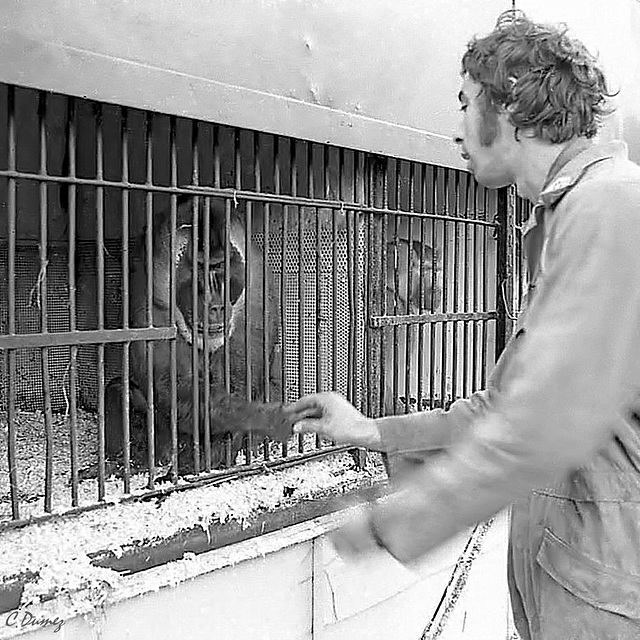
[120,107,131,493]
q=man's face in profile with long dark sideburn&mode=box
[455,74,515,188]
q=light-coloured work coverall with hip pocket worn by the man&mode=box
[372,140,640,640]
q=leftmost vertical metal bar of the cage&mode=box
[6,85,20,520]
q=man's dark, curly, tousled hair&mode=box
[462,10,614,143]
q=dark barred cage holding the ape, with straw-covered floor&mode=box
[0,86,507,520]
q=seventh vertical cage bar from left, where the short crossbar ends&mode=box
[169,116,178,484]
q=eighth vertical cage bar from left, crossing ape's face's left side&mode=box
[191,121,200,474]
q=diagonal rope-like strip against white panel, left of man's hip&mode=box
[420,518,495,640]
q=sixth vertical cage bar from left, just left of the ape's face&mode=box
[144,112,156,490]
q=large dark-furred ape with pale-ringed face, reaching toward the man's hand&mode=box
[106,197,292,466]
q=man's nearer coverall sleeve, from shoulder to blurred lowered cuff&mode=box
[371,181,640,562]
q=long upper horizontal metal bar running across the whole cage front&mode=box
[0,170,500,227]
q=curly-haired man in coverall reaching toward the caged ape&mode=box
[293,12,640,640]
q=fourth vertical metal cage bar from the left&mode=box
[95,104,106,500]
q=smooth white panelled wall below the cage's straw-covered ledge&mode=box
[0,514,509,640]
